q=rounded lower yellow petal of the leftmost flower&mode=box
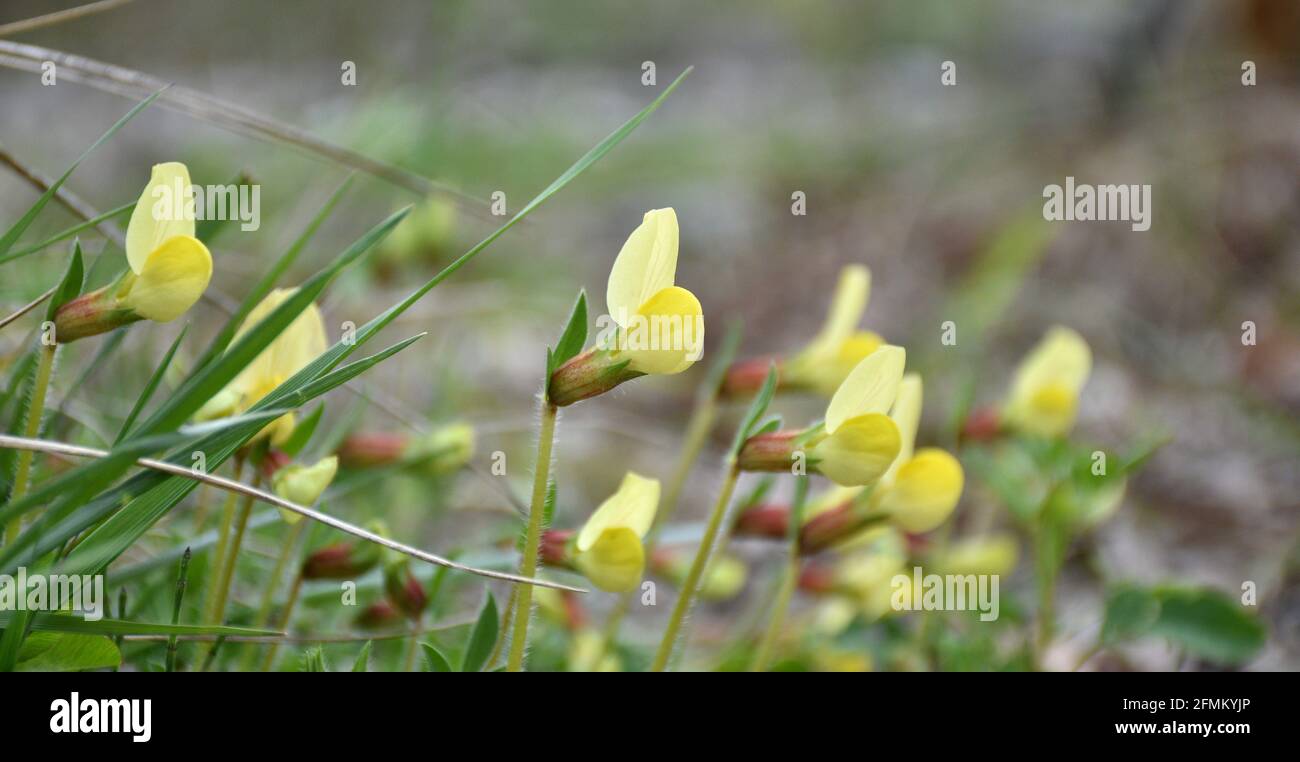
[122,235,212,322]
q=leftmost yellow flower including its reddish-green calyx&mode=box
[55,161,212,342]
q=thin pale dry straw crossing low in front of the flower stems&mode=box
[0,434,586,593]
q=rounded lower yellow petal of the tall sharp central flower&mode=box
[620,286,705,376]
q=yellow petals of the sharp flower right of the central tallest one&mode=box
[809,345,906,486]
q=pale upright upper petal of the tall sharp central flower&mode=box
[605,208,677,325]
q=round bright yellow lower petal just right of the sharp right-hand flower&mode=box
[878,447,965,533]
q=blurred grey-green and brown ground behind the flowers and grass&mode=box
[0,0,1300,670]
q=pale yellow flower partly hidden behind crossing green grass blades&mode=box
[195,289,326,445]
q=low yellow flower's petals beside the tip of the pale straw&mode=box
[573,471,659,593]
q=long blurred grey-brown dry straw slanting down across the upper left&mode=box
[0,40,486,209]
